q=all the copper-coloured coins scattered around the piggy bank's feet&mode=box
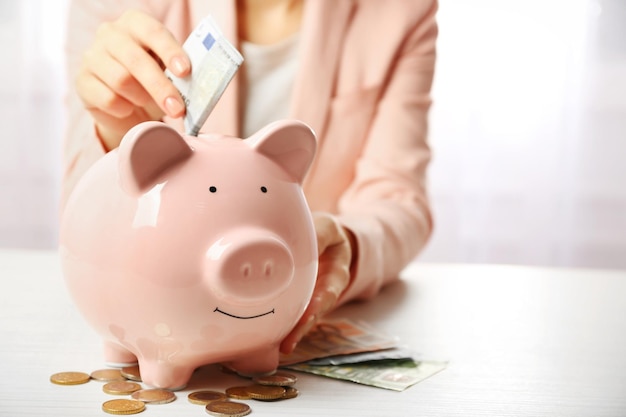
[50,366,298,417]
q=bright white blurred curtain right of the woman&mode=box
[421,0,626,269]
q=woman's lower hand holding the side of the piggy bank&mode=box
[280,213,357,354]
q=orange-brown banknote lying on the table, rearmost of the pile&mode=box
[280,319,398,366]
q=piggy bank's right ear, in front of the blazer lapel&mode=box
[249,120,317,184]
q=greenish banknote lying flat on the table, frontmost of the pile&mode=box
[287,359,447,391]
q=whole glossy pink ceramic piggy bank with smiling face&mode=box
[59,121,318,389]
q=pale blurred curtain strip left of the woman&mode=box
[0,0,67,248]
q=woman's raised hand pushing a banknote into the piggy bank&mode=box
[76,10,191,150]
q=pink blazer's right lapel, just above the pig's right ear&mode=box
[291,0,355,144]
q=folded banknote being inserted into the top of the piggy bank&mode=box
[165,16,243,136]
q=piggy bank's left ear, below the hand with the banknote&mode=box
[119,118,193,194]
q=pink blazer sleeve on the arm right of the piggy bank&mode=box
[338,1,437,302]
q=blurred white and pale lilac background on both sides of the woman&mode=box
[0,0,626,269]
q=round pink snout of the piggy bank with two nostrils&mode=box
[207,228,295,305]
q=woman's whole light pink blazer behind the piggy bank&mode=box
[62,0,437,301]
